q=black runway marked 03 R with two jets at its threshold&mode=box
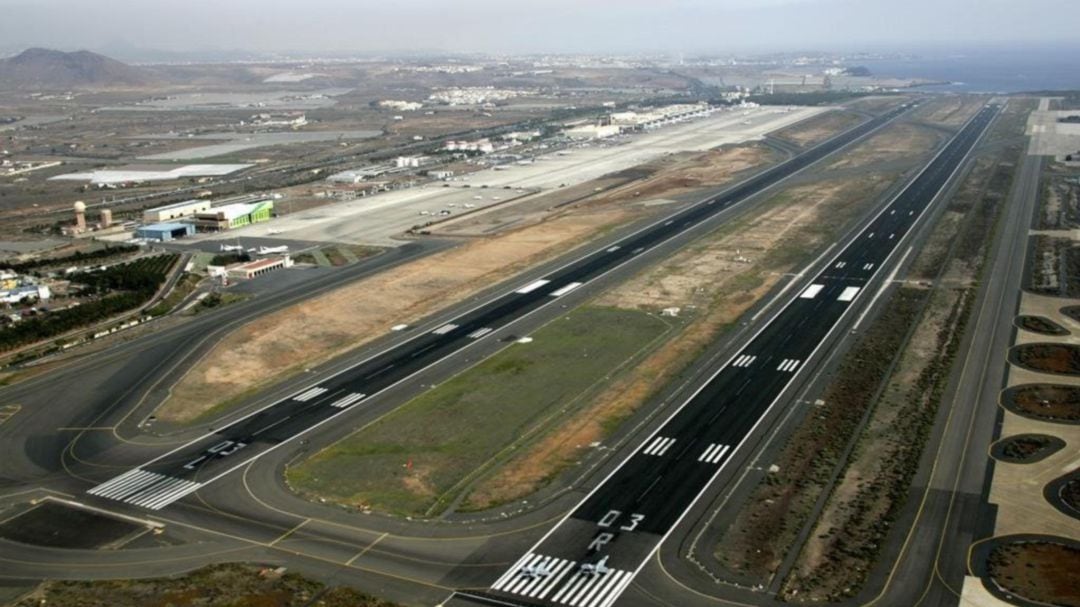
[460,105,999,607]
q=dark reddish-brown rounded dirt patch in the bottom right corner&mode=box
[986,541,1080,607]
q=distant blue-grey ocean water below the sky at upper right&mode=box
[861,49,1080,93]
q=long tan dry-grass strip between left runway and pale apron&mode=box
[158,208,633,422]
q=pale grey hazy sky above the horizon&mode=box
[0,0,1080,53]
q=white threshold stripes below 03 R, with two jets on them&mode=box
[491,552,634,607]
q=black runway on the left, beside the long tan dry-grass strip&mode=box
[79,104,912,510]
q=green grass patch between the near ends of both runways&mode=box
[287,307,669,515]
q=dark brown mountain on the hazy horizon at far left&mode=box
[0,49,153,90]
